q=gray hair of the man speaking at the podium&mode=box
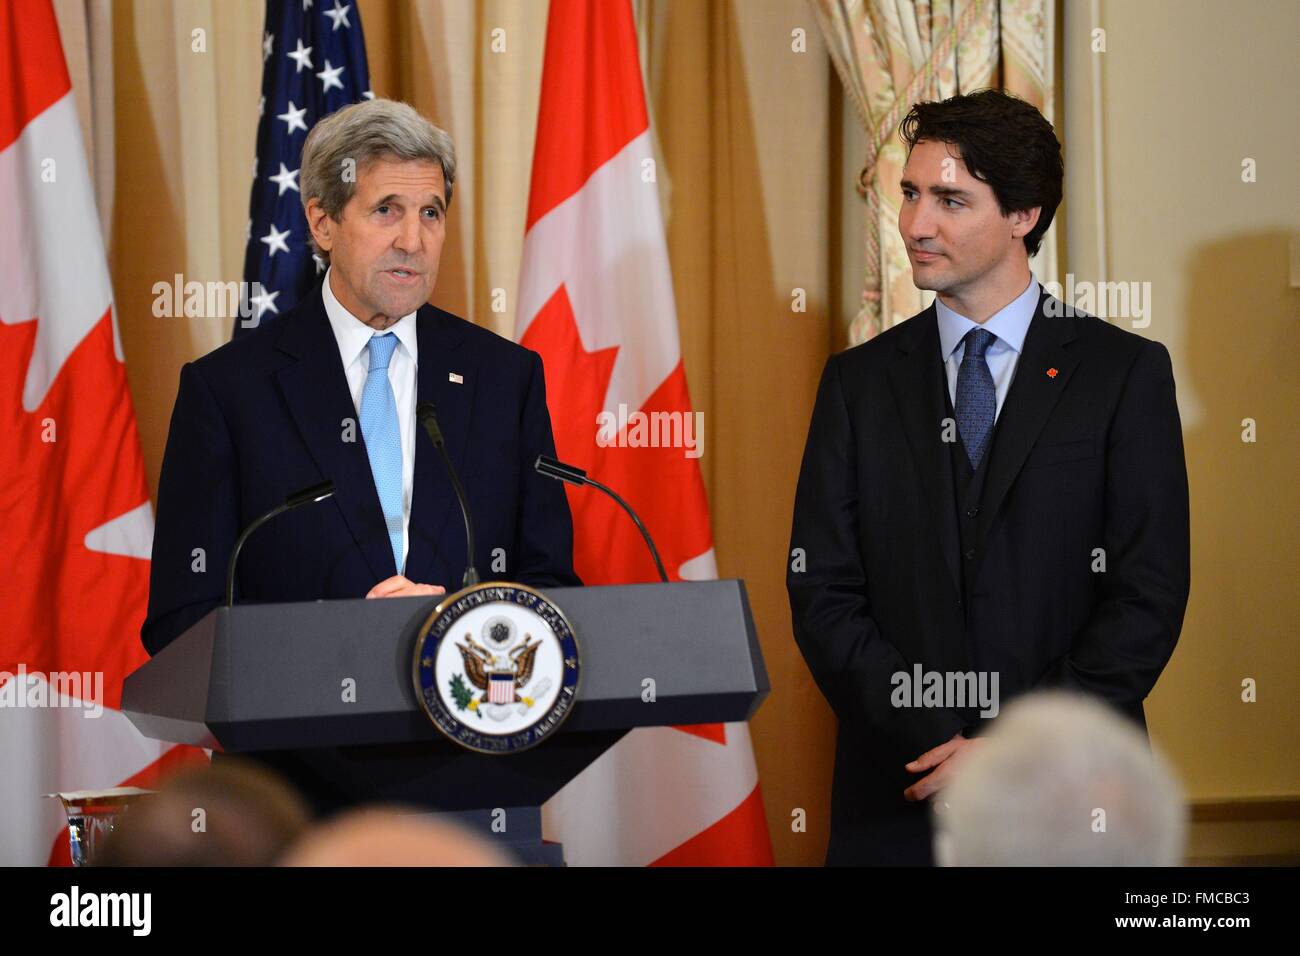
[298,99,456,260]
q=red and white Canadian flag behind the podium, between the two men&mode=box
[516,0,772,866]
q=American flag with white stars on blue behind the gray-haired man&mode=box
[234,0,374,337]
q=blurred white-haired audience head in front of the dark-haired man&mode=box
[931,692,1187,866]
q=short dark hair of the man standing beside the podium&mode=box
[898,90,1065,256]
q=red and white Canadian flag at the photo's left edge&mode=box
[0,0,203,865]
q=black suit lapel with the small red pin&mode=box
[976,291,1079,561]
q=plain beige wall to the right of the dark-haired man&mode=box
[1065,0,1300,816]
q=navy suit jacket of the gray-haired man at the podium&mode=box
[140,285,581,654]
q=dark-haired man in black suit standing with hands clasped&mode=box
[787,91,1190,865]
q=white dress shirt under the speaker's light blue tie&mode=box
[321,269,420,572]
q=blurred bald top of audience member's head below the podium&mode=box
[281,809,514,866]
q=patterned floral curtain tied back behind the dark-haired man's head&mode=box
[809,0,1061,345]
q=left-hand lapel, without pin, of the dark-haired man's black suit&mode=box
[889,306,962,606]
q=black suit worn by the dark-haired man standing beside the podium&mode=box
[787,290,1191,864]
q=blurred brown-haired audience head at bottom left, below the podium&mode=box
[95,761,309,866]
